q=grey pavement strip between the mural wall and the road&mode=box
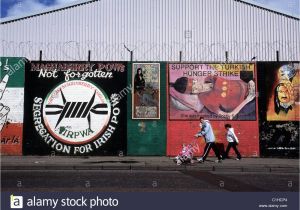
[0,156,299,174]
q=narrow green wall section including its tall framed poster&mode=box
[127,62,167,156]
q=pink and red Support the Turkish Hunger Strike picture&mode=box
[168,64,256,120]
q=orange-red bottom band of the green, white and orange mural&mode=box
[0,123,23,155]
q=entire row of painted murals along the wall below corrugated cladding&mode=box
[0,58,300,157]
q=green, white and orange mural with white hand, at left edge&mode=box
[0,57,26,155]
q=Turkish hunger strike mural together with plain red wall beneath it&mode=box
[167,63,260,157]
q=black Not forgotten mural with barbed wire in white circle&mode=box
[25,62,129,155]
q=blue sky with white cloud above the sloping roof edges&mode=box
[0,0,300,18]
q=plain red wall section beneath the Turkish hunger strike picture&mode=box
[167,121,259,157]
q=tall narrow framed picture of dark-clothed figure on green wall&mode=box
[132,63,160,119]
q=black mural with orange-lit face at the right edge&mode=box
[257,62,300,157]
